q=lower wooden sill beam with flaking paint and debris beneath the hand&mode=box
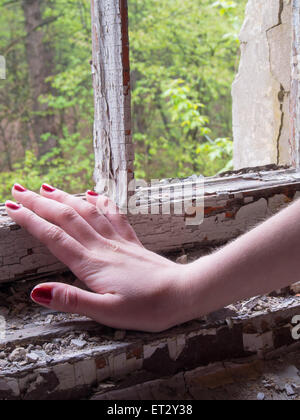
[0,288,300,399]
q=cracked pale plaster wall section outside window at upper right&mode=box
[232,0,292,169]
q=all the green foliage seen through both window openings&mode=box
[0,0,246,201]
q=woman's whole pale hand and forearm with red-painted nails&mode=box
[6,184,300,332]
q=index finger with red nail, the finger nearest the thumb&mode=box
[6,201,88,275]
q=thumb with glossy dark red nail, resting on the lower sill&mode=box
[31,283,113,324]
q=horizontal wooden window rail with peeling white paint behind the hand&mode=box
[0,170,300,283]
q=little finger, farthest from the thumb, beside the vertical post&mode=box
[86,191,143,246]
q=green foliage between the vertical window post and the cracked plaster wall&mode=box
[129,0,246,178]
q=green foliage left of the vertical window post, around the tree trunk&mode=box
[0,0,94,201]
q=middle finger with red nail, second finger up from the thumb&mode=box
[12,184,101,249]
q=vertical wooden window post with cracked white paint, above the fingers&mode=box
[92,0,134,209]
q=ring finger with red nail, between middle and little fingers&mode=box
[40,184,118,239]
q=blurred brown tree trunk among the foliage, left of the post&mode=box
[22,0,57,156]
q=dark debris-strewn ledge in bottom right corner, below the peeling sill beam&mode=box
[90,352,300,400]
